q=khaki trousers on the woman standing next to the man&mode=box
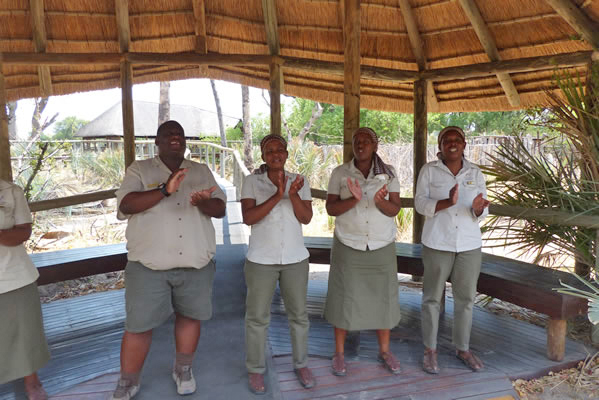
[244,259,310,374]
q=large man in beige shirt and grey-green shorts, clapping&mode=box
[111,121,226,400]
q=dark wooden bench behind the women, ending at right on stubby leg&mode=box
[304,237,587,361]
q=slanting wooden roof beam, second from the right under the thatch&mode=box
[460,0,520,107]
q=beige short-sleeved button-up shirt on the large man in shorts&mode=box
[116,156,226,270]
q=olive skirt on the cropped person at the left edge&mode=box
[0,282,50,384]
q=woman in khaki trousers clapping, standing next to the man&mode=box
[241,135,315,394]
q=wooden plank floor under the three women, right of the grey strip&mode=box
[269,281,587,400]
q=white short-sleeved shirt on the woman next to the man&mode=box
[241,171,312,265]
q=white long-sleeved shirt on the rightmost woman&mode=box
[414,159,489,252]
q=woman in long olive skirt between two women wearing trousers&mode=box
[324,128,401,376]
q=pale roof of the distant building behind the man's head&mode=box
[75,101,240,138]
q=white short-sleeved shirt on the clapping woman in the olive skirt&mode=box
[327,160,399,251]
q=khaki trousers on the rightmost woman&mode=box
[422,246,482,351]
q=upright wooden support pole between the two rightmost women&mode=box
[412,80,428,243]
